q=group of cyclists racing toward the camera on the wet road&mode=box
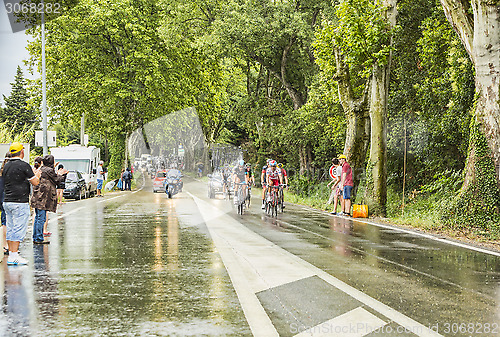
[222,159,288,209]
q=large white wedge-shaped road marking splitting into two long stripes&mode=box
[188,192,441,336]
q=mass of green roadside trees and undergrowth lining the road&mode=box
[0,0,500,240]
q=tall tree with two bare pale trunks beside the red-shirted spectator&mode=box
[315,0,396,214]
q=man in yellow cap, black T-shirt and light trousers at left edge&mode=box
[3,142,41,265]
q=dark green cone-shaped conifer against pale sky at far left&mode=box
[0,66,38,137]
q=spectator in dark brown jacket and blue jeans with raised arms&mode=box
[31,155,68,244]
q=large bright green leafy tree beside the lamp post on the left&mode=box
[30,0,223,175]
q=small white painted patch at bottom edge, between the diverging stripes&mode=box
[295,307,387,337]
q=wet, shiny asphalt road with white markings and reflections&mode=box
[0,177,500,336]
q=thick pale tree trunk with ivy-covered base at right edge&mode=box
[441,0,500,224]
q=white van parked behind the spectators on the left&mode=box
[50,144,101,197]
